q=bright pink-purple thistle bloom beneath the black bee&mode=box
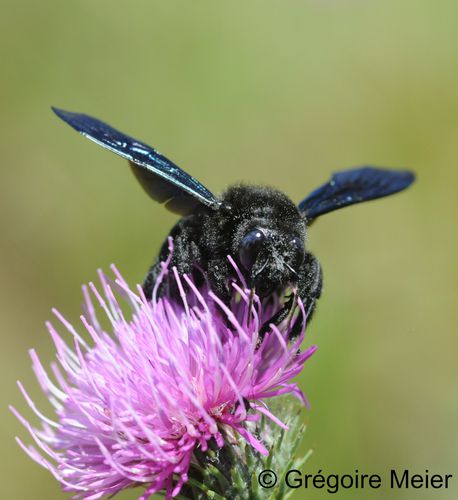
[11,241,316,499]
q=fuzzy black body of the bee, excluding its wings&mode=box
[144,185,322,318]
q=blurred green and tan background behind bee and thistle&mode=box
[0,0,458,499]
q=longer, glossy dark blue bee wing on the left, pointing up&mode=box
[52,108,221,215]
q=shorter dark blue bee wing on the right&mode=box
[299,167,415,221]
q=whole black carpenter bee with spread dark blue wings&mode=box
[53,108,415,334]
